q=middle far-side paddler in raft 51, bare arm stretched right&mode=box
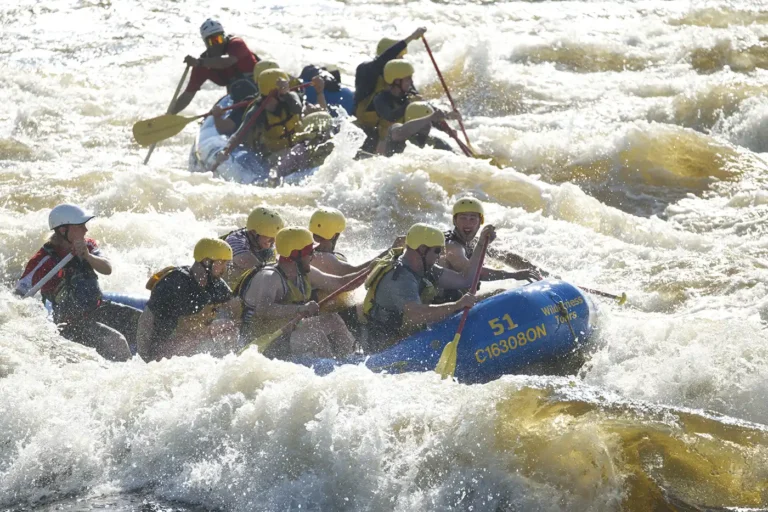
[309,207,404,276]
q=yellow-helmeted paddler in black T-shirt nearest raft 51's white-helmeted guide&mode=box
[136,238,240,361]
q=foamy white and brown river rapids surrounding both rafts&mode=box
[0,0,768,511]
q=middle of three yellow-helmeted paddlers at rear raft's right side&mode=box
[373,59,418,155]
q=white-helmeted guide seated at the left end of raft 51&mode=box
[16,204,141,361]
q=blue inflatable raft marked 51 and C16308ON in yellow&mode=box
[105,280,593,383]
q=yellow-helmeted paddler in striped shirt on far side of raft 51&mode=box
[221,206,285,286]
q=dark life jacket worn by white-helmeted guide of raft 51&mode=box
[43,243,102,323]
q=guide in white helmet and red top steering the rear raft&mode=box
[171,18,260,114]
